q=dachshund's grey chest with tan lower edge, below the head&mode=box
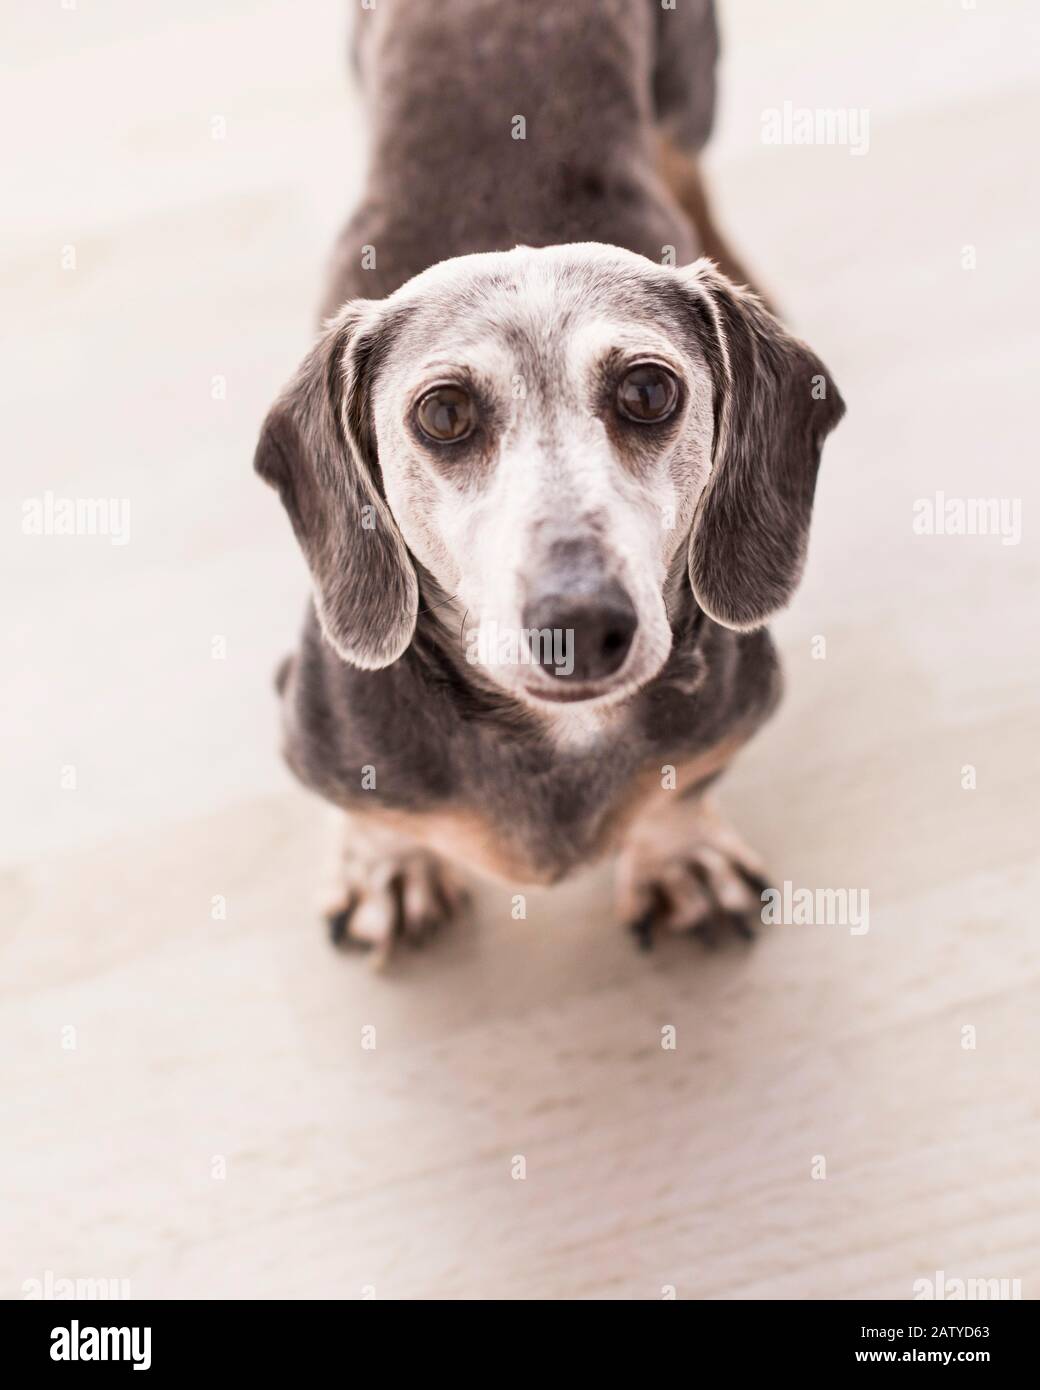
[284,619,777,884]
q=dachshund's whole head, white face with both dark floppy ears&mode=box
[257,245,843,703]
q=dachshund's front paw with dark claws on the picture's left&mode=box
[325,849,467,965]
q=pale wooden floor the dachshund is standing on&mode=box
[0,0,1040,1298]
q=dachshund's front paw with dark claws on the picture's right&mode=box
[620,816,769,951]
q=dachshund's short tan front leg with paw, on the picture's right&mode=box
[617,791,767,949]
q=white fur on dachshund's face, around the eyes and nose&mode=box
[374,246,713,709]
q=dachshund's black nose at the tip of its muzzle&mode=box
[523,580,638,681]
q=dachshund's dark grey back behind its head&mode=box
[324,0,717,313]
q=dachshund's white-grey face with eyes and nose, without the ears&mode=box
[371,250,712,701]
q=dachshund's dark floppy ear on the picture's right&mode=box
[684,260,845,630]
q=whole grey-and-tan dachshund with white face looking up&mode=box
[257,0,841,949]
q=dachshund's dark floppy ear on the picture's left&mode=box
[254,300,419,670]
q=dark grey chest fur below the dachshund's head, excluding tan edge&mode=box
[276,588,780,881]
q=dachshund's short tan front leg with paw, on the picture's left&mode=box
[325,813,467,965]
